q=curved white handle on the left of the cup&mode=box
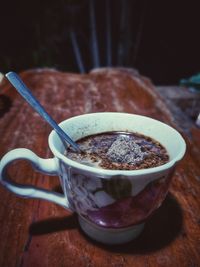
[0,148,69,209]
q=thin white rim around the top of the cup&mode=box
[48,112,186,177]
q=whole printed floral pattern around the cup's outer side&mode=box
[60,162,171,228]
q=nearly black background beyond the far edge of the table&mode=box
[0,0,200,84]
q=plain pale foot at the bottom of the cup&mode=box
[78,216,144,245]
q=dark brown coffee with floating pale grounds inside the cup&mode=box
[65,132,169,170]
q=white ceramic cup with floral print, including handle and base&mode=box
[0,112,186,244]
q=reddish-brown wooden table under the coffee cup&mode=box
[0,69,200,267]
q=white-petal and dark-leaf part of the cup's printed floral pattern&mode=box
[60,161,132,216]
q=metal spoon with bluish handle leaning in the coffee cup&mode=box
[6,71,81,152]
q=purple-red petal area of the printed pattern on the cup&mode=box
[87,176,171,228]
